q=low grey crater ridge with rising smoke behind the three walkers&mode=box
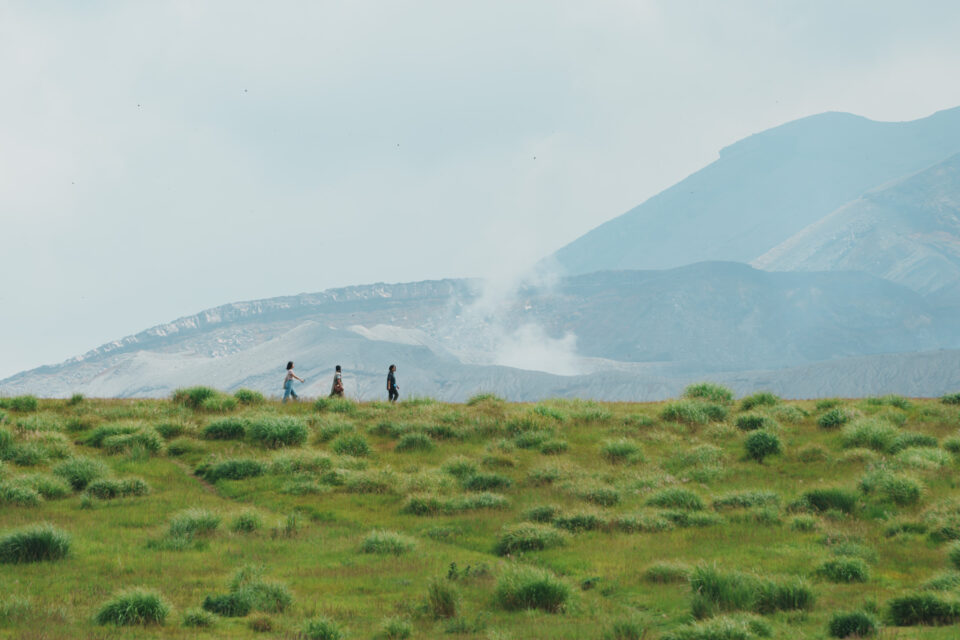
[0,263,960,400]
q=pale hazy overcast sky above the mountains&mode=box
[0,0,960,377]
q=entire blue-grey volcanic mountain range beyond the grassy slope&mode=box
[0,108,960,400]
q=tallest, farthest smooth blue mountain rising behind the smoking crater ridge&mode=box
[553,107,960,274]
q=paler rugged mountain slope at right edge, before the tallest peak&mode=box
[753,155,960,298]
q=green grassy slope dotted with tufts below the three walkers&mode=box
[0,386,960,640]
